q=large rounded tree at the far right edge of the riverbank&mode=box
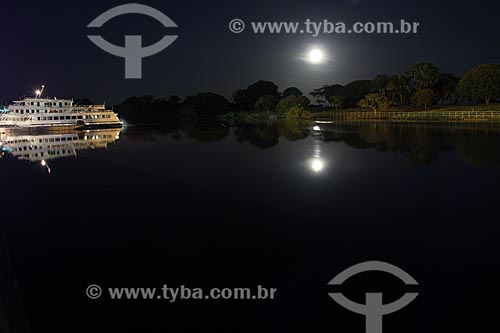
[458,64,500,104]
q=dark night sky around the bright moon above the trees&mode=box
[0,0,500,104]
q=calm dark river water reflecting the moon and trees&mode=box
[0,121,500,333]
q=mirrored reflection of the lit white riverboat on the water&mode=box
[0,128,121,173]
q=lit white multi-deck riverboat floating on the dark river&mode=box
[0,87,123,129]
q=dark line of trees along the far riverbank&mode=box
[114,63,500,123]
